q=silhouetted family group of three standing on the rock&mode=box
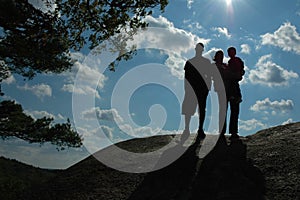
[181,43,245,141]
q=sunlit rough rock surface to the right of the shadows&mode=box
[247,123,300,200]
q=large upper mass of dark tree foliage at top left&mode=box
[0,0,168,83]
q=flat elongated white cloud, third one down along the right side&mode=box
[250,98,294,115]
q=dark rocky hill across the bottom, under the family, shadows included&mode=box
[0,123,300,200]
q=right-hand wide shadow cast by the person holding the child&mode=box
[190,136,265,200]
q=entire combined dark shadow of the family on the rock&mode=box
[128,136,265,200]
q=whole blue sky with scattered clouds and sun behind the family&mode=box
[0,0,300,168]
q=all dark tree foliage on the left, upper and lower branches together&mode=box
[0,0,168,148]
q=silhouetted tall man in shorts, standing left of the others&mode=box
[182,43,211,139]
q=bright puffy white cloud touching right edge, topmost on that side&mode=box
[260,22,300,54]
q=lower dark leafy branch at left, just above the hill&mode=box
[0,101,82,150]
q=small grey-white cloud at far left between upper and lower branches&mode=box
[18,83,52,99]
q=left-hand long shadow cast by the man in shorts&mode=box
[128,134,201,200]
